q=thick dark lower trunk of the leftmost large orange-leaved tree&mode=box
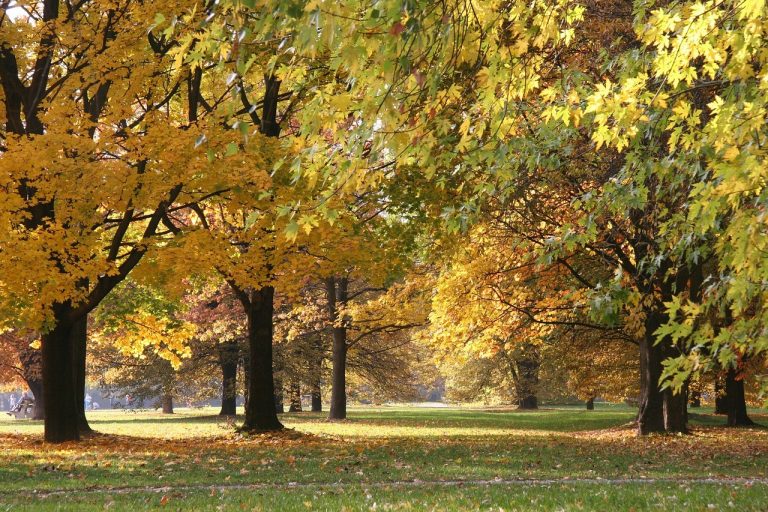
[42,304,80,443]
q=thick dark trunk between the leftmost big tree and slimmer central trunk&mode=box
[242,286,283,431]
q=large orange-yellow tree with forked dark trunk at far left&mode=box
[0,0,249,442]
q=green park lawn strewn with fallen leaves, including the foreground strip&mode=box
[0,404,768,511]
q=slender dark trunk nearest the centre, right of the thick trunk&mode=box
[326,277,348,420]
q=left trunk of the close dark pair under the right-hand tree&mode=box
[637,310,665,435]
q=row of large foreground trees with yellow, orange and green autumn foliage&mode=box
[0,0,768,441]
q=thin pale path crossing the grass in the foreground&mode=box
[10,477,768,498]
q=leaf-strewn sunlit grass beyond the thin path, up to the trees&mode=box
[0,407,768,504]
